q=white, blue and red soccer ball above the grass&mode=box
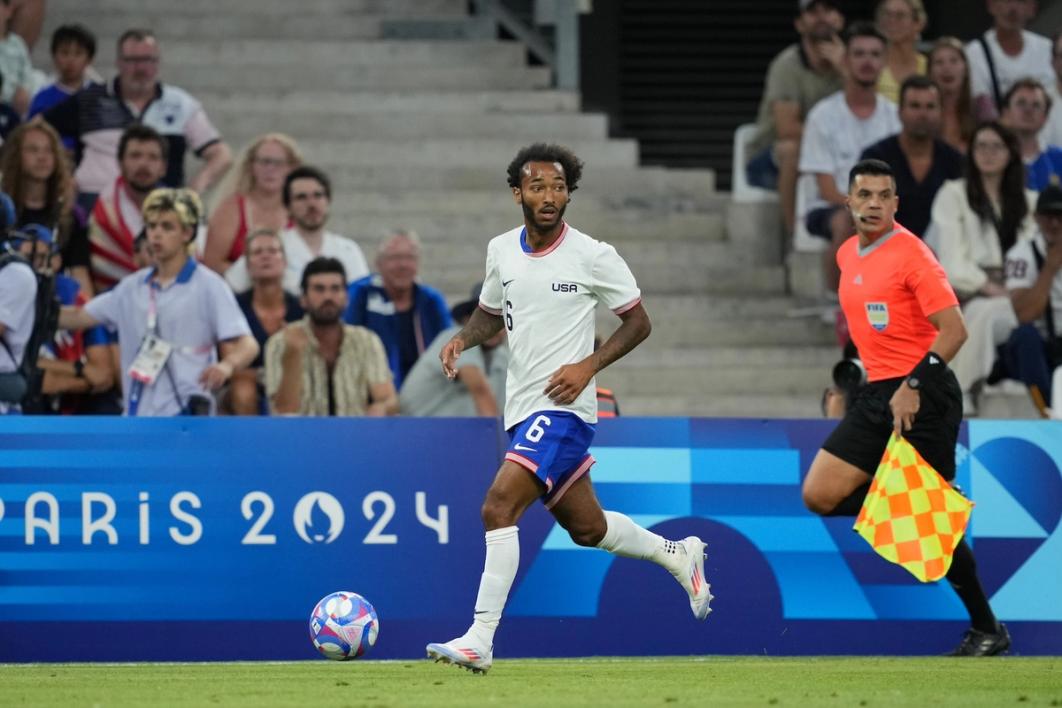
[310,590,380,661]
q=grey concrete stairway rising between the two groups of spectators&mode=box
[36,0,837,417]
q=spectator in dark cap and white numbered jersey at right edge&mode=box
[1003,185,1062,416]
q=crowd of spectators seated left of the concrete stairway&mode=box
[0,16,508,416]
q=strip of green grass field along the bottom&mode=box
[0,657,1062,708]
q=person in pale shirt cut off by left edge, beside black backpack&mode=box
[0,232,37,415]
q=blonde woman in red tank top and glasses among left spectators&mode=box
[202,133,303,273]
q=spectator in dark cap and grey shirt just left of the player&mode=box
[398,283,509,417]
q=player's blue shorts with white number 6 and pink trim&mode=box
[506,411,595,508]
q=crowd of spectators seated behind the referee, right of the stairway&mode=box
[747,0,1062,416]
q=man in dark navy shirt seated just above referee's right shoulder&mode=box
[861,74,962,237]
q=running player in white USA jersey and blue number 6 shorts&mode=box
[427,143,712,672]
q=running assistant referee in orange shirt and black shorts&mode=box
[803,160,1010,656]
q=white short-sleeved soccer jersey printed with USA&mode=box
[479,225,641,429]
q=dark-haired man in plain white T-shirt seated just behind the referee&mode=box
[797,22,902,291]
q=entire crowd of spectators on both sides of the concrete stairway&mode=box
[0,0,1062,415]
